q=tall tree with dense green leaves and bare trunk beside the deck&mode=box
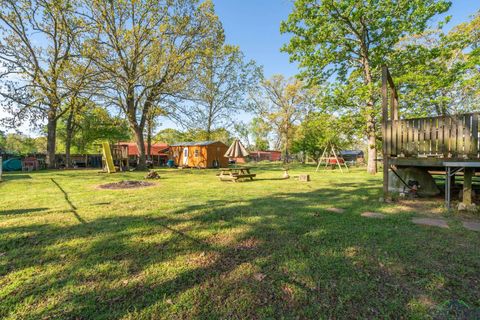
[281,0,450,174]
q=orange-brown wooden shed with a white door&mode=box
[170,141,228,168]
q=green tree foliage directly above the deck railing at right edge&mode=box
[393,14,480,117]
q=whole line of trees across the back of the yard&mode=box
[0,0,480,173]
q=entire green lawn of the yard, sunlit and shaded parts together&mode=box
[0,165,480,319]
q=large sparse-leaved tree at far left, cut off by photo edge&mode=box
[0,0,88,167]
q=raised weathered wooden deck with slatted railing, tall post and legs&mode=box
[382,66,480,208]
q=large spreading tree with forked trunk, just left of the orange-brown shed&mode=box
[86,0,222,169]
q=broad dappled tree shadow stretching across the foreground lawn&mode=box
[0,180,480,319]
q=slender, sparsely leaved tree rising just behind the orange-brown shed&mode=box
[170,44,261,140]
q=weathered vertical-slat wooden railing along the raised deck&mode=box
[384,113,480,159]
